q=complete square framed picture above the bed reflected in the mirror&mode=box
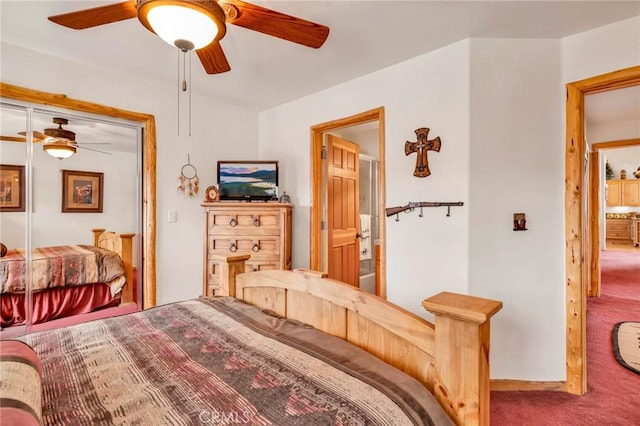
[62,170,104,213]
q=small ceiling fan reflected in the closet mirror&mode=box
[0,117,111,159]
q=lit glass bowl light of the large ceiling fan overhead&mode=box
[138,0,226,50]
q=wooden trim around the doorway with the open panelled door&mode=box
[309,107,386,298]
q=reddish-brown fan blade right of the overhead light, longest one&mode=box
[220,0,329,49]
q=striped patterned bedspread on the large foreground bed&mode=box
[21,298,452,426]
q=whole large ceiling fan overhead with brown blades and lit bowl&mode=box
[49,0,329,74]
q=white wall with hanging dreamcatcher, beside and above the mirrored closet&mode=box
[0,43,258,304]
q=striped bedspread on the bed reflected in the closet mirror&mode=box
[0,245,125,294]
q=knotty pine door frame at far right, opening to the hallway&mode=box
[564,66,640,395]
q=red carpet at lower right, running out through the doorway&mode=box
[491,250,640,426]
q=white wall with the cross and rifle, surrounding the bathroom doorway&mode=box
[260,41,469,322]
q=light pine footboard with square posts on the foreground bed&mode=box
[214,254,502,426]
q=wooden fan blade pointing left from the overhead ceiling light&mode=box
[48,0,138,30]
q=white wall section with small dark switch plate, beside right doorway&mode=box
[469,39,566,380]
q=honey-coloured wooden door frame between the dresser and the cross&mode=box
[309,107,387,299]
